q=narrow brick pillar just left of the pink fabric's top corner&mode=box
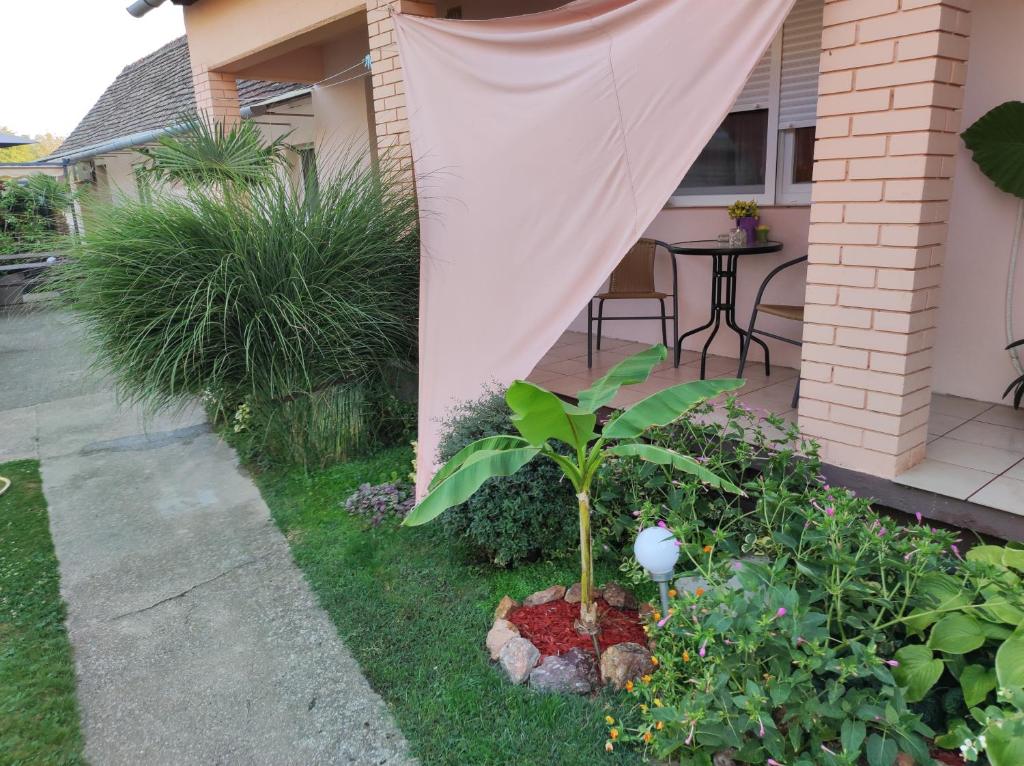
[367,0,437,172]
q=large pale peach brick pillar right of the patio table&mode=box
[800,0,971,477]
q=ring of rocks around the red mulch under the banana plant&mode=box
[484,583,654,694]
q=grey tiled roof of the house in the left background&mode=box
[51,36,304,158]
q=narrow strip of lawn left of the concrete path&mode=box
[0,460,85,766]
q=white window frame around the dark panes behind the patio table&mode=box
[666,29,813,208]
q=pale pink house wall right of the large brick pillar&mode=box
[932,0,1024,401]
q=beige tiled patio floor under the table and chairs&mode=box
[527,332,1024,515]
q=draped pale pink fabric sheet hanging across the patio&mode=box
[395,0,794,495]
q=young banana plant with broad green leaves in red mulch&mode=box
[403,345,743,635]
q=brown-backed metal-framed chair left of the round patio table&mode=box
[587,239,679,368]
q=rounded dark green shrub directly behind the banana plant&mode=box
[438,390,580,566]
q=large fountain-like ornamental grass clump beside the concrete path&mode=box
[62,139,419,466]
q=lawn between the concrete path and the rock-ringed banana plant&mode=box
[257,449,641,766]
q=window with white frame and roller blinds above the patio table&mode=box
[671,0,824,206]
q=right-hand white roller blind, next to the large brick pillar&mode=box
[782,0,824,130]
